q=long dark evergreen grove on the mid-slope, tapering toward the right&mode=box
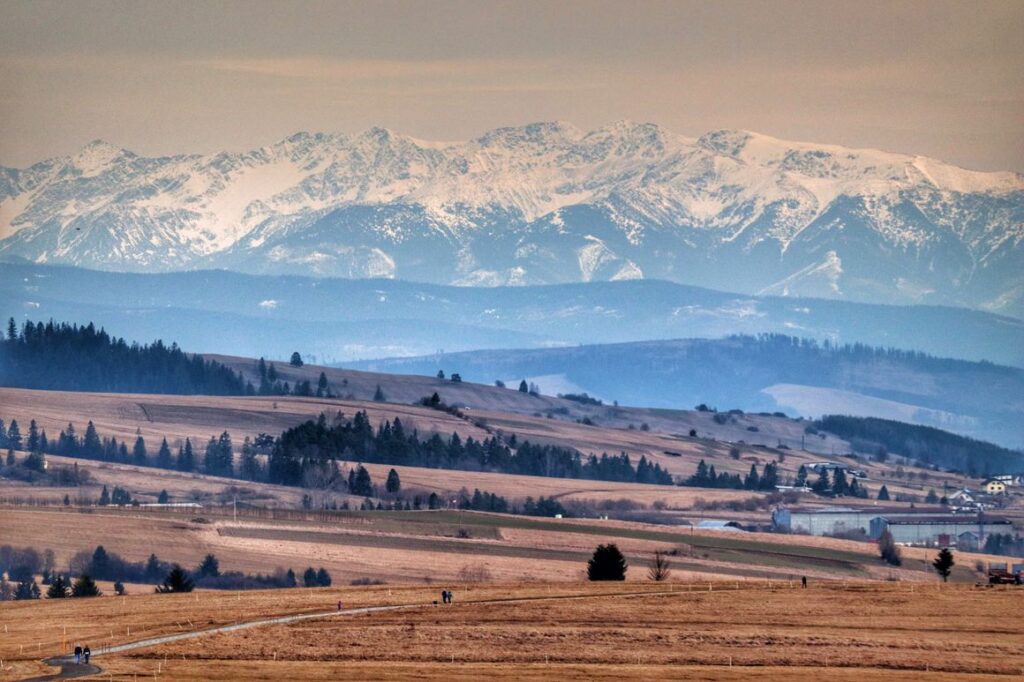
[267,412,672,485]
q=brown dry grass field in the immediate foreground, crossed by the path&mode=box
[0,582,1024,682]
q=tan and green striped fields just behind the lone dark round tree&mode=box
[0,507,993,589]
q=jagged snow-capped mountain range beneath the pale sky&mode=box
[0,122,1024,316]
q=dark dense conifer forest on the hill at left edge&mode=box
[0,319,253,395]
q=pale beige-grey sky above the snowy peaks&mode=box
[0,0,1024,172]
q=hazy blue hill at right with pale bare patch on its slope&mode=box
[344,336,1024,449]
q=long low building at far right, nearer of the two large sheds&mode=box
[868,513,1014,549]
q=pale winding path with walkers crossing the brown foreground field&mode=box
[30,590,675,682]
